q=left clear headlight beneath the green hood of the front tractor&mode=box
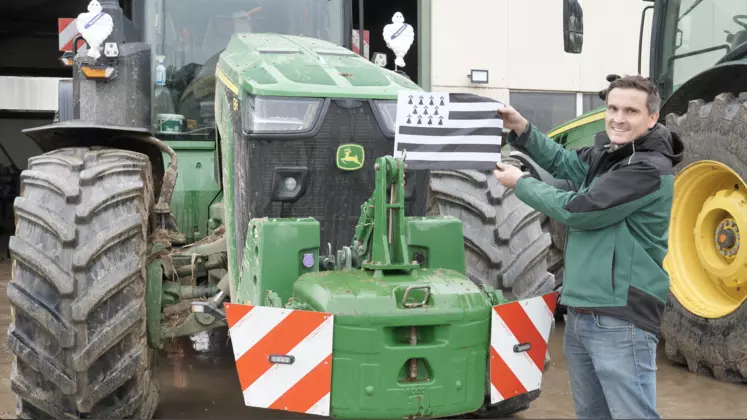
[242,96,322,134]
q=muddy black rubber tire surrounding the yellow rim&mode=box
[661,93,747,382]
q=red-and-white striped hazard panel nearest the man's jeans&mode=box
[490,292,558,404]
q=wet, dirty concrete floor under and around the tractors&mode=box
[0,263,747,419]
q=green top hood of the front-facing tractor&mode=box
[217,34,422,99]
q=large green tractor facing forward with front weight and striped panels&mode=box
[7,0,555,418]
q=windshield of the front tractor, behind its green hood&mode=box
[144,0,351,140]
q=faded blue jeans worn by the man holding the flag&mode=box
[563,308,661,419]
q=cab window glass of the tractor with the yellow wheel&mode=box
[656,0,747,97]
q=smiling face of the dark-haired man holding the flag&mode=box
[605,88,659,145]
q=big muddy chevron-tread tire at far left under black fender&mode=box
[7,148,159,419]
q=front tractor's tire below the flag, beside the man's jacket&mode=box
[428,158,555,300]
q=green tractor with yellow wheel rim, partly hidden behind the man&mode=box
[511,0,747,382]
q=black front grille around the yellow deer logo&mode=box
[235,100,427,257]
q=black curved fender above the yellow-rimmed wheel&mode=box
[659,60,747,120]
